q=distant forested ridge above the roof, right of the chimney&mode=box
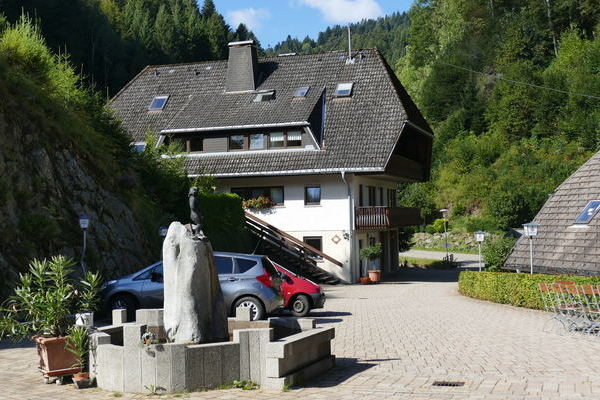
[267,13,408,60]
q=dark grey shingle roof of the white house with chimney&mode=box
[112,50,431,176]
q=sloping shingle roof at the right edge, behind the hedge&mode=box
[505,153,600,275]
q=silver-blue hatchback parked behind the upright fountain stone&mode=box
[102,252,283,320]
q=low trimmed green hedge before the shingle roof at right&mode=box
[458,271,600,310]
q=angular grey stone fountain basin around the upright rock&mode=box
[90,308,335,393]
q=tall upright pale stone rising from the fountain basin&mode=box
[163,222,229,343]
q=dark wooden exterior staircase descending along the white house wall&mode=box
[246,213,343,285]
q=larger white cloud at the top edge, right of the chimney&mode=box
[302,0,383,24]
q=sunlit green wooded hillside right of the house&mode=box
[390,0,600,229]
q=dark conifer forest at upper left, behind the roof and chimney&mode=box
[0,0,256,95]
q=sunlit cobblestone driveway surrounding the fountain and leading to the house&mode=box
[0,270,600,400]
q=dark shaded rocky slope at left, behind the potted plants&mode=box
[0,107,160,302]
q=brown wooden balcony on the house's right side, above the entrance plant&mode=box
[354,206,422,230]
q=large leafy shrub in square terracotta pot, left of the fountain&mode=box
[0,256,100,381]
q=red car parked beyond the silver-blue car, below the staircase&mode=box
[273,263,325,317]
